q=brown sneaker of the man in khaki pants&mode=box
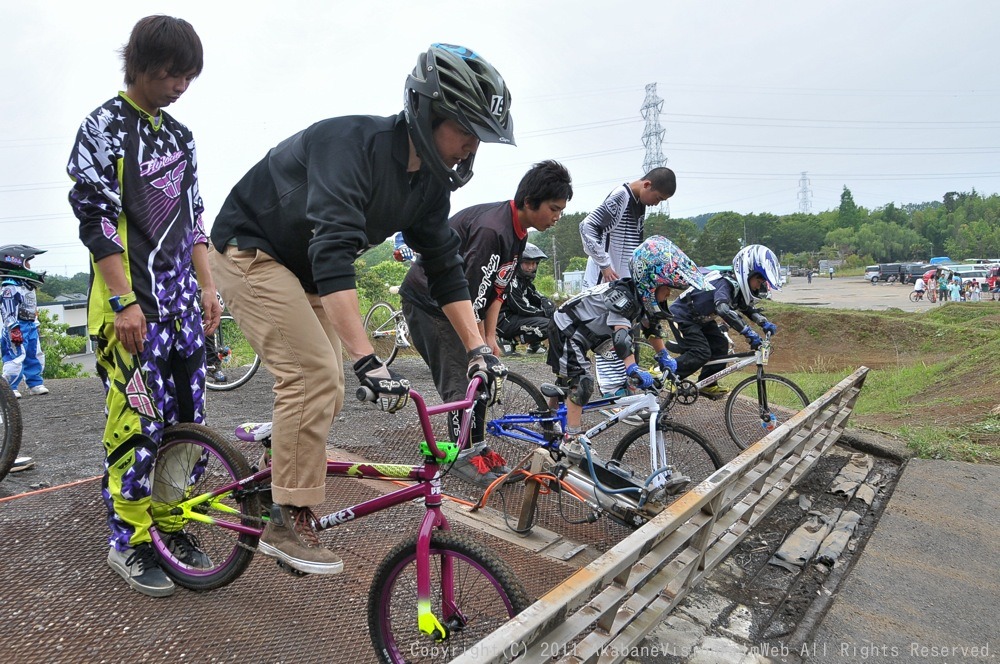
[257,505,344,574]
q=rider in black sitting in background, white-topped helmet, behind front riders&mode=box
[497,242,555,355]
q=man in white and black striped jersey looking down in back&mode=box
[580,167,677,402]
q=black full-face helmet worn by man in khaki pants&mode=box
[403,44,514,191]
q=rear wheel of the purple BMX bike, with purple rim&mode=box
[150,424,263,590]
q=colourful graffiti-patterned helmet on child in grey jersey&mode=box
[629,235,709,316]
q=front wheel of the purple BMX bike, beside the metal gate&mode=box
[368,530,531,662]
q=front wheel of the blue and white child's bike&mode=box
[611,417,722,500]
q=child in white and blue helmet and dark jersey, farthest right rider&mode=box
[670,244,781,399]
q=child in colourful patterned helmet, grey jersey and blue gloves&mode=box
[548,235,706,438]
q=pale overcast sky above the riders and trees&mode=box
[0,0,1000,274]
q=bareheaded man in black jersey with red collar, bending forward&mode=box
[399,161,573,485]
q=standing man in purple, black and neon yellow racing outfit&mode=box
[67,16,222,597]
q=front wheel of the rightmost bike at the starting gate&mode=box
[726,374,809,450]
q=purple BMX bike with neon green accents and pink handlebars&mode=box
[151,375,530,662]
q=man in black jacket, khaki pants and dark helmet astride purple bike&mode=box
[211,44,514,574]
